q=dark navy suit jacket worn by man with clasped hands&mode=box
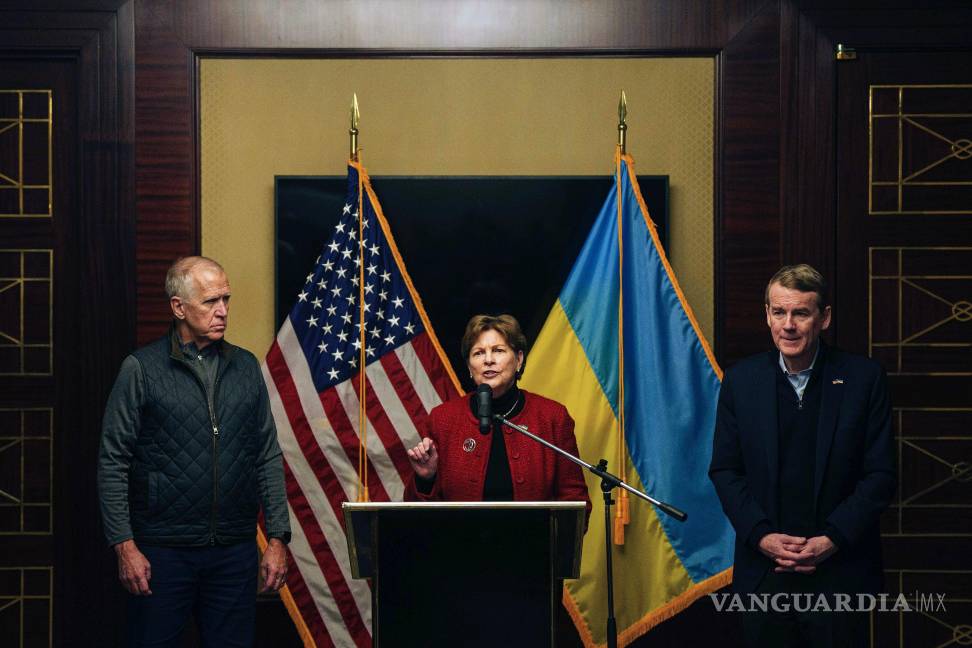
[709,343,897,593]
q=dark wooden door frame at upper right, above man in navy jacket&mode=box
[780,2,972,351]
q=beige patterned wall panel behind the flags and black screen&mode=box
[199,58,715,355]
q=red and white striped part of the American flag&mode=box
[263,319,457,647]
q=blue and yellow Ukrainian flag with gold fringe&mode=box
[522,155,733,647]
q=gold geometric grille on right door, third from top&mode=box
[882,407,972,538]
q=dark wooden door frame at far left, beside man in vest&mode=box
[0,0,136,646]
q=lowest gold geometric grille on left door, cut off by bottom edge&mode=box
[0,567,54,648]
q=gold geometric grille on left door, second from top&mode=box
[0,250,54,376]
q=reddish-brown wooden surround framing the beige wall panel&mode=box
[135,0,782,359]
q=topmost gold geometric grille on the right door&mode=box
[868,85,972,214]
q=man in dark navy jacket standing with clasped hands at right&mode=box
[709,265,896,647]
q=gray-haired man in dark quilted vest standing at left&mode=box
[98,256,290,648]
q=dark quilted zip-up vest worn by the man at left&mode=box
[129,335,265,545]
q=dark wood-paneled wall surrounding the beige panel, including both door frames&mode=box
[0,0,972,646]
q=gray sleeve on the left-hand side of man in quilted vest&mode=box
[98,356,144,545]
